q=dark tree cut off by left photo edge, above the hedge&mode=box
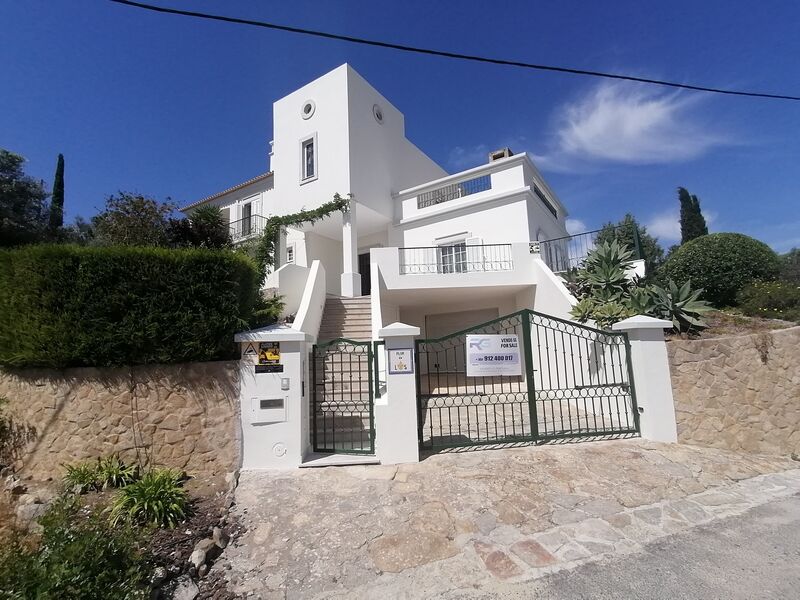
[0,148,47,246]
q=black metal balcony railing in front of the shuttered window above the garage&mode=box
[399,243,514,275]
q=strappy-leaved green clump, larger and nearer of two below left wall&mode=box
[111,469,189,527]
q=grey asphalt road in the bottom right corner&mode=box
[456,496,800,600]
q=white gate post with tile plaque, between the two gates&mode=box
[374,323,419,465]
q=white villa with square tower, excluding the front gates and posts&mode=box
[183,64,571,339]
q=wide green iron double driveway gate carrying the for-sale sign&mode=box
[416,310,639,450]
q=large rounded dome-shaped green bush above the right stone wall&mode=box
[664,233,780,307]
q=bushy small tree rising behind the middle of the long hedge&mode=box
[92,192,175,246]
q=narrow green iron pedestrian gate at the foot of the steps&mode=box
[311,338,375,454]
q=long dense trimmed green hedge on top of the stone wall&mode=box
[0,245,259,367]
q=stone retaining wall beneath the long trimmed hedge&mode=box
[0,361,241,479]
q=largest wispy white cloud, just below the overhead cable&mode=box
[536,83,731,170]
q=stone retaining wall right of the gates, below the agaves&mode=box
[667,327,800,455]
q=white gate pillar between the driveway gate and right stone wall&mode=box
[612,315,678,442]
